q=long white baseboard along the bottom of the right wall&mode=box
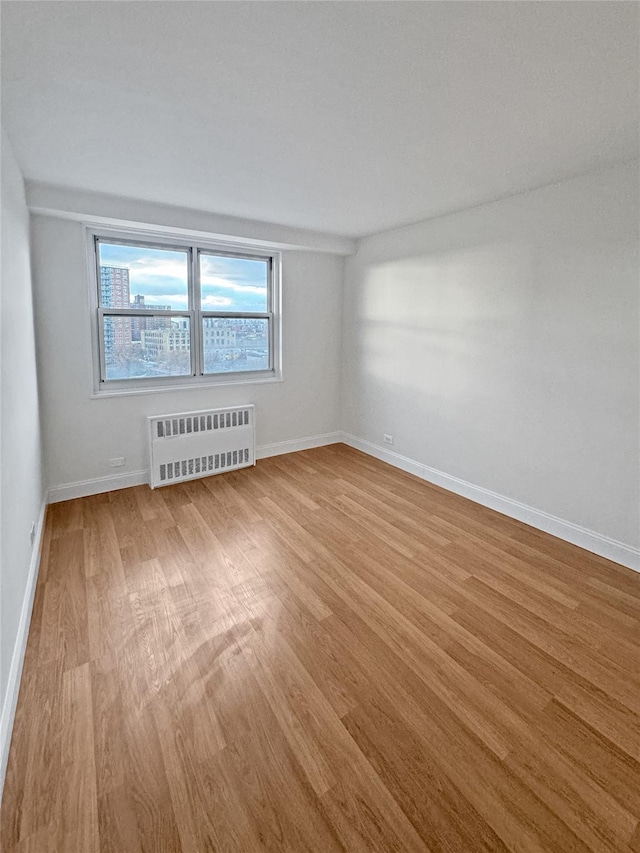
[342,433,640,572]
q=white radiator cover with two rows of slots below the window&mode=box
[147,405,256,489]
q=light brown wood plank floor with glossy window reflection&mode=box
[2,445,640,853]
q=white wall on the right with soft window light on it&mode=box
[343,163,640,547]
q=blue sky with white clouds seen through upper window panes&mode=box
[99,243,267,312]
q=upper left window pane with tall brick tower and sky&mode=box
[98,243,189,311]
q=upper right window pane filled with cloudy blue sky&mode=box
[200,252,269,314]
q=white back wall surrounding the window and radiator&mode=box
[32,216,344,496]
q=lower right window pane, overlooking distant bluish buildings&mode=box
[202,317,269,373]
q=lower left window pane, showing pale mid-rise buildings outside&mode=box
[104,317,191,379]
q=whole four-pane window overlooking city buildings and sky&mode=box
[90,232,280,393]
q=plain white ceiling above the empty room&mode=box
[2,0,640,236]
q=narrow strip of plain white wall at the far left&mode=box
[0,125,43,789]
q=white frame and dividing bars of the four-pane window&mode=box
[85,225,282,397]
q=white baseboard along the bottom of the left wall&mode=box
[0,500,47,802]
